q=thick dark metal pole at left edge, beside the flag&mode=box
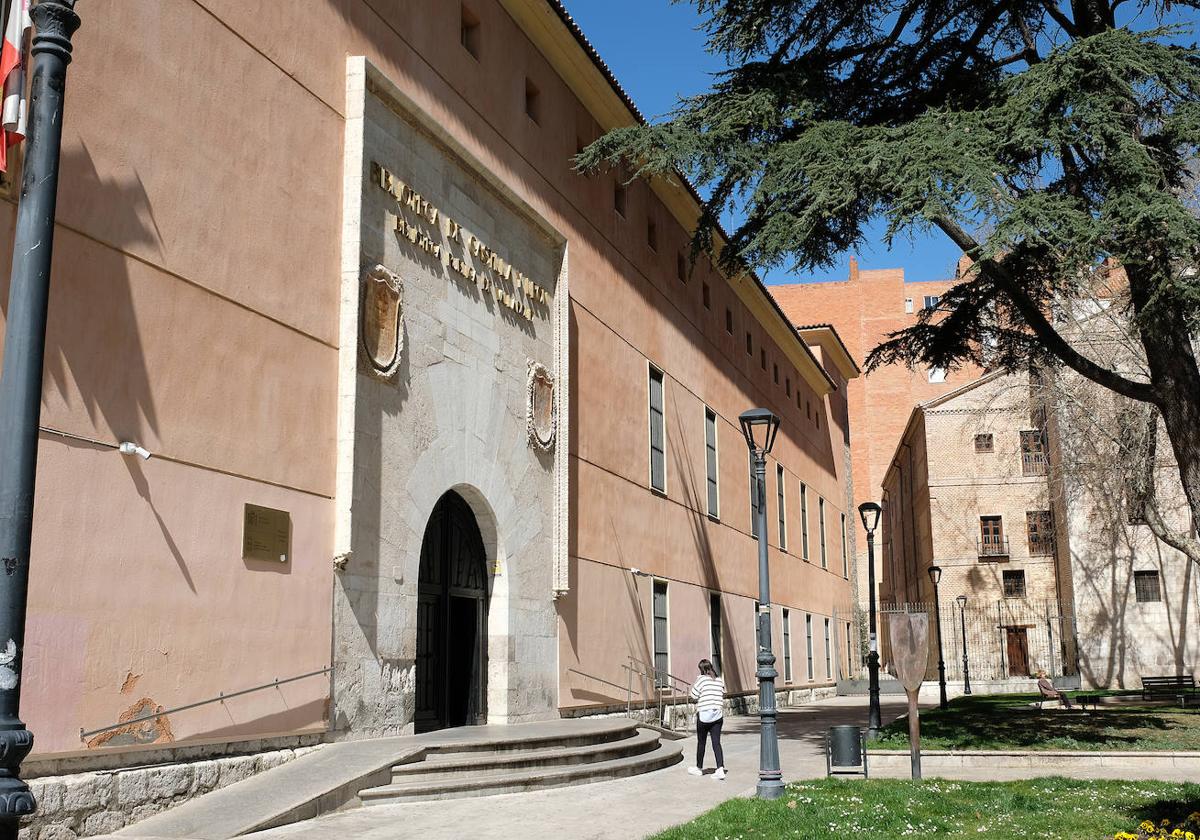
[0,0,79,840]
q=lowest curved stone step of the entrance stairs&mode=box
[359,742,683,806]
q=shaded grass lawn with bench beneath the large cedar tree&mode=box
[874,695,1200,750]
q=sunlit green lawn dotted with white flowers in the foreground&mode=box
[655,778,1200,840]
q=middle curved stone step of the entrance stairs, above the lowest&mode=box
[391,728,659,784]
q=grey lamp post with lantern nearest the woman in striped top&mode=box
[738,408,784,799]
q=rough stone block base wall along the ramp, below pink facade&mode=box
[19,746,320,840]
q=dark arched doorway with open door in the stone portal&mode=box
[414,491,487,732]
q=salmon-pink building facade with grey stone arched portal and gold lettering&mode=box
[0,0,858,792]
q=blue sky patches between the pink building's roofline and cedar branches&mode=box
[564,0,959,283]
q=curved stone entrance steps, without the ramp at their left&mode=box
[359,720,683,805]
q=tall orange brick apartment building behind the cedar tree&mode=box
[769,258,979,602]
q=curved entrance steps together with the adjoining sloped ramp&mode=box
[118,718,683,840]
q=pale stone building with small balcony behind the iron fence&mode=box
[880,372,1075,680]
